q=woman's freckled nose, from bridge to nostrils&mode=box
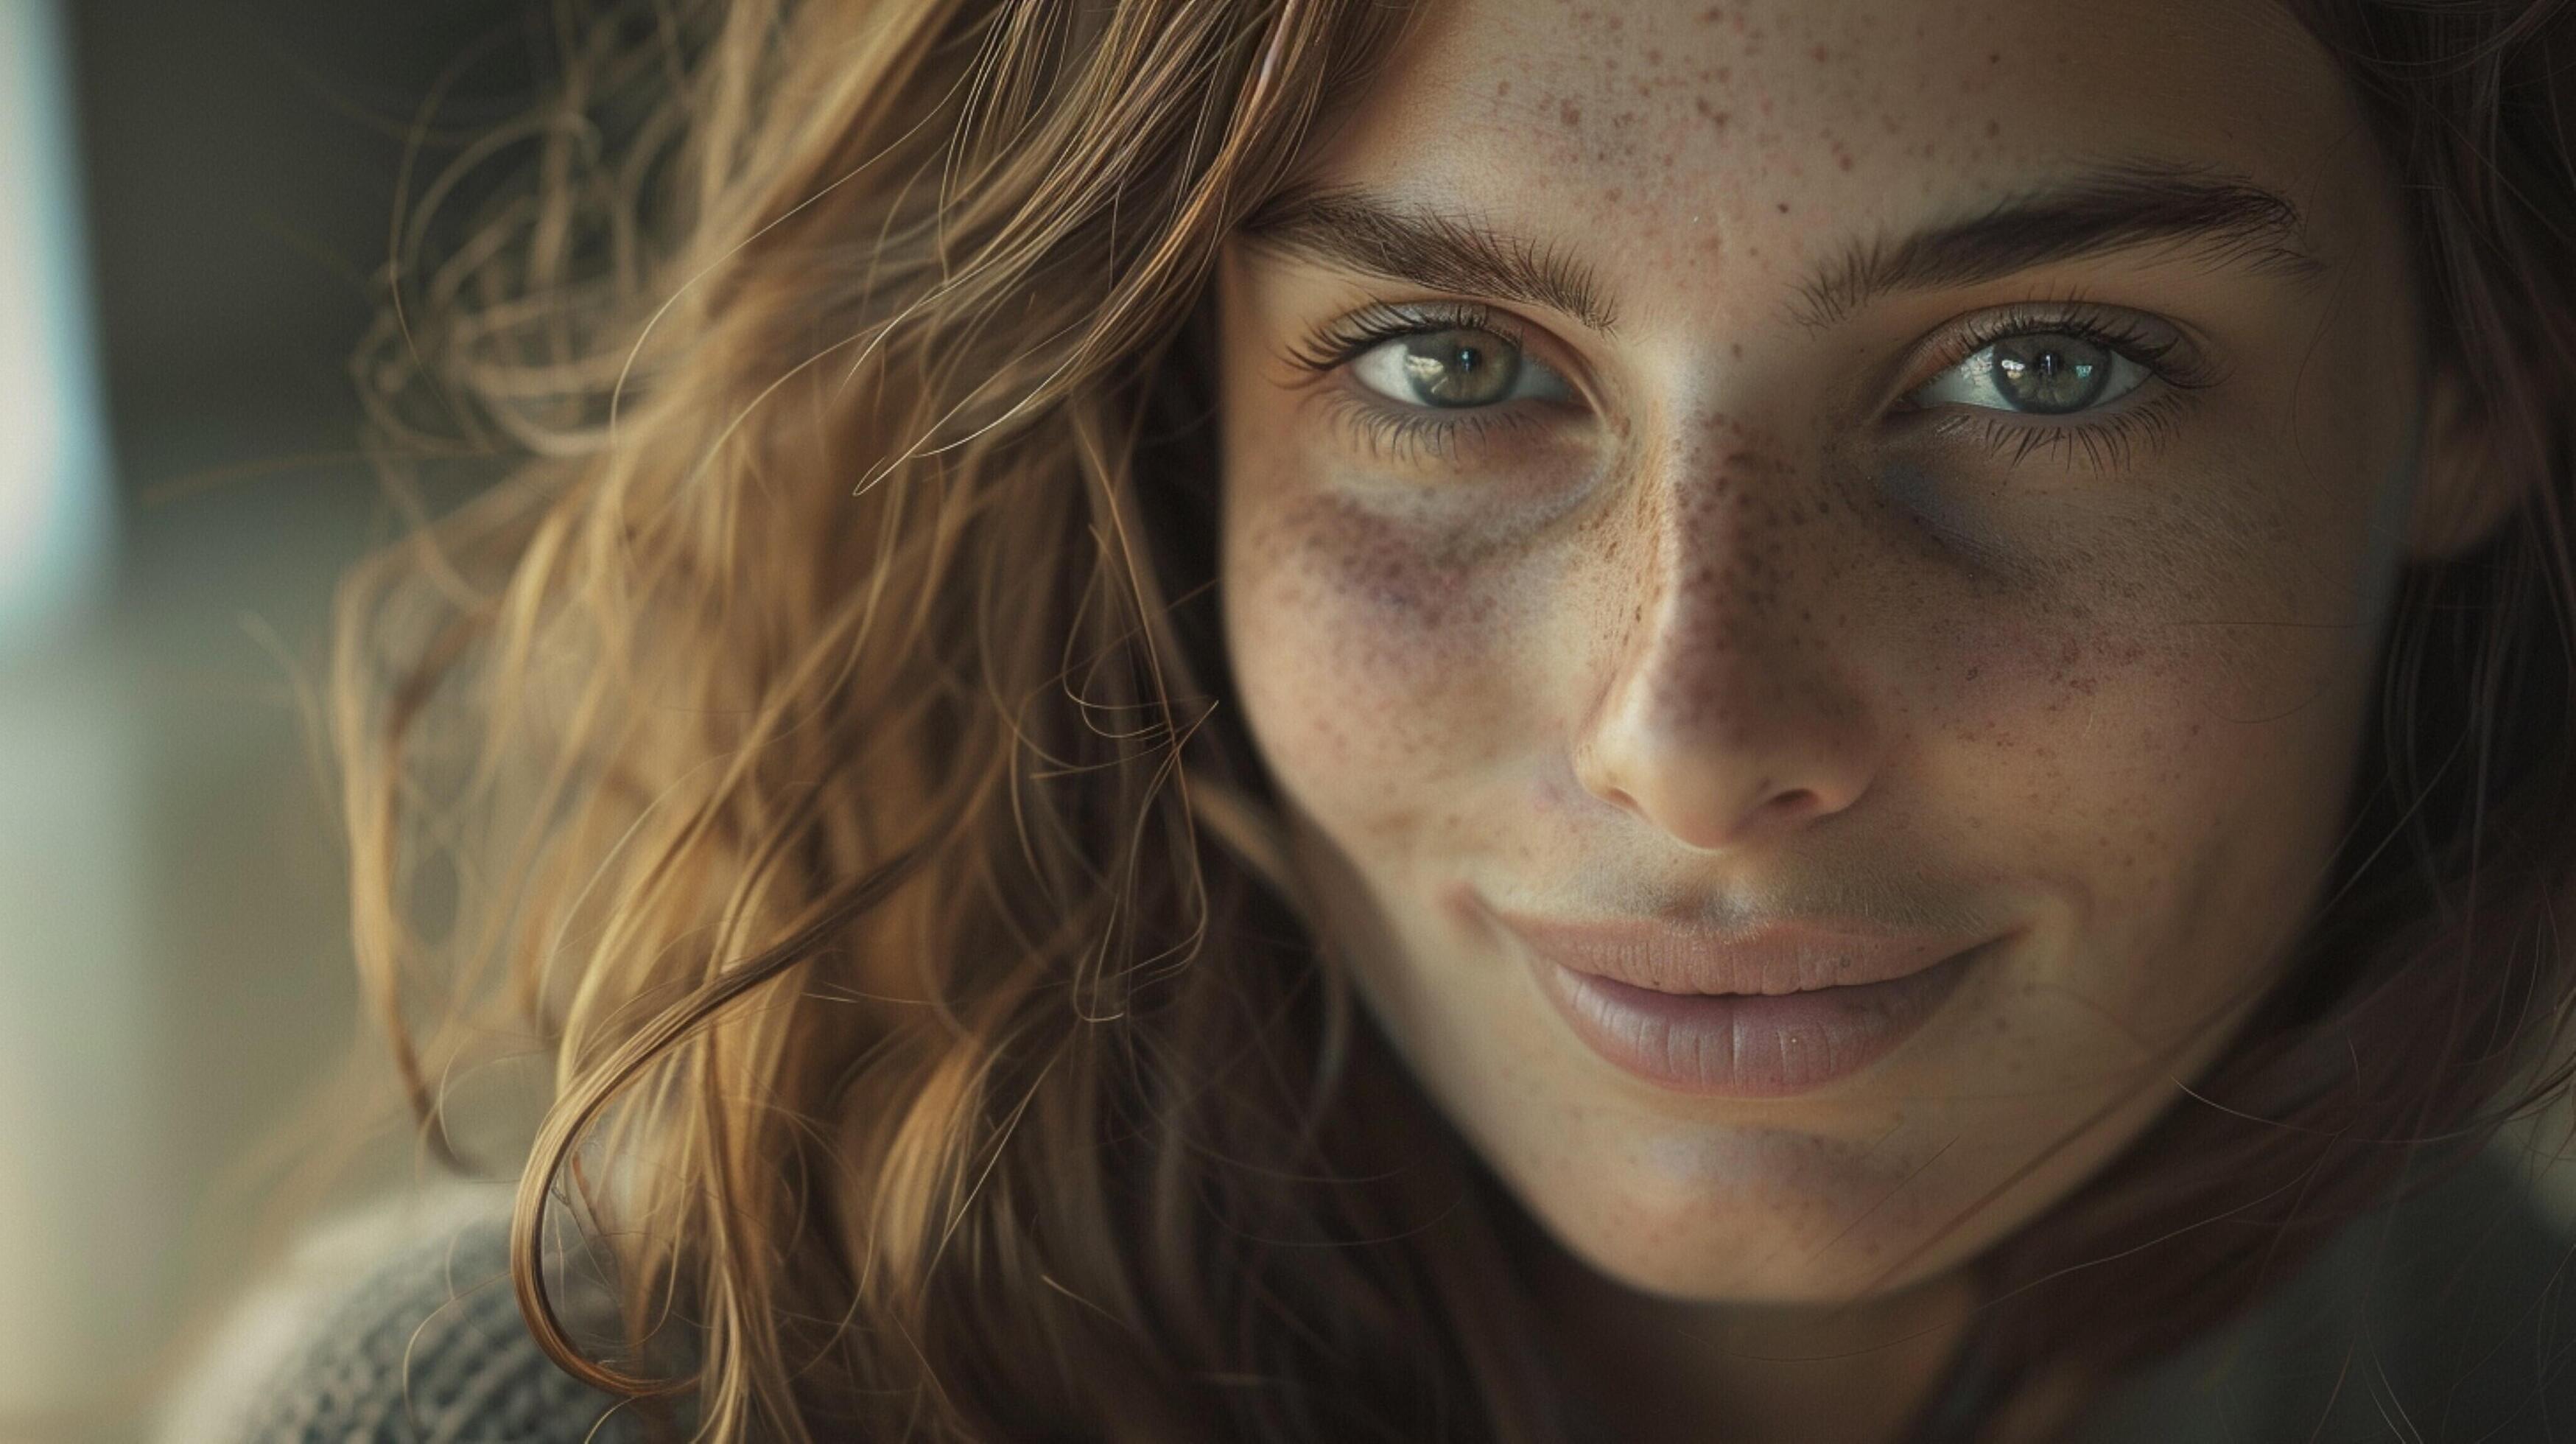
[1574,456,1881,851]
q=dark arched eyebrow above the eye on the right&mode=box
[1790,160,2326,330]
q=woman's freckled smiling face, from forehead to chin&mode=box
[1221,0,2421,1303]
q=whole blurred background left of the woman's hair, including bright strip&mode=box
[0,0,556,1442]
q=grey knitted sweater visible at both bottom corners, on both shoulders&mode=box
[160,1160,2576,1444]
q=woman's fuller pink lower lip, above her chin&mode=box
[1530,947,1986,1098]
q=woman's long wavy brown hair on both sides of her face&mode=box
[332,0,2576,1439]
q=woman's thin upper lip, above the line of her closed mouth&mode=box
[1494,911,1981,993]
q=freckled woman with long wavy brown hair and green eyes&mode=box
[200,0,2576,1439]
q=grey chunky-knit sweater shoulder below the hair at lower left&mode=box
[157,1184,642,1444]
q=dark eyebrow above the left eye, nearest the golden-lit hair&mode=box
[1239,186,1618,330]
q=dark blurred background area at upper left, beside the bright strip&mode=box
[64,0,533,498]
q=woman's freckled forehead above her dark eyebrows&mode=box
[1306,0,2385,300]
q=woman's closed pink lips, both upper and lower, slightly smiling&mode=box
[1494,913,1991,1098]
